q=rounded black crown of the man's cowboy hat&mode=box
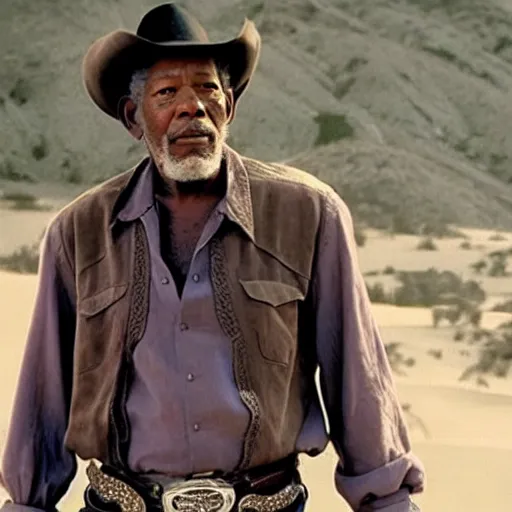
[137,3,208,43]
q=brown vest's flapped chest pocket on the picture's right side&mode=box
[240,279,304,366]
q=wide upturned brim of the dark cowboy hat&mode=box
[82,20,261,119]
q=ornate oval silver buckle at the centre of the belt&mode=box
[162,478,235,512]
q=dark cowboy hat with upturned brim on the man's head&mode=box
[82,3,261,119]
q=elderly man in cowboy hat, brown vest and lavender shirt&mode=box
[2,4,424,512]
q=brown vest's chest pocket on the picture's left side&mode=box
[75,284,128,373]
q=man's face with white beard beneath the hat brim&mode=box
[138,59,232,181]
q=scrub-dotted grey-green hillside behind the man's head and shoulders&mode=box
[0,0,512,229]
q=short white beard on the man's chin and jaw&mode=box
[149,127,228,182]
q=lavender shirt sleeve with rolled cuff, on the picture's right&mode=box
[312,190,424,512]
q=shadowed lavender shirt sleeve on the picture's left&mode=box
[0,222,77,512]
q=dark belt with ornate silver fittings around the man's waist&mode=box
[85,455,307,512]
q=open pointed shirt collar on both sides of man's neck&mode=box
[111,145,254,241]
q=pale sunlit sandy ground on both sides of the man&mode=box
[0,206,512,512]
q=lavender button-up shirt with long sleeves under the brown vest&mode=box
[1,158,424,512]
